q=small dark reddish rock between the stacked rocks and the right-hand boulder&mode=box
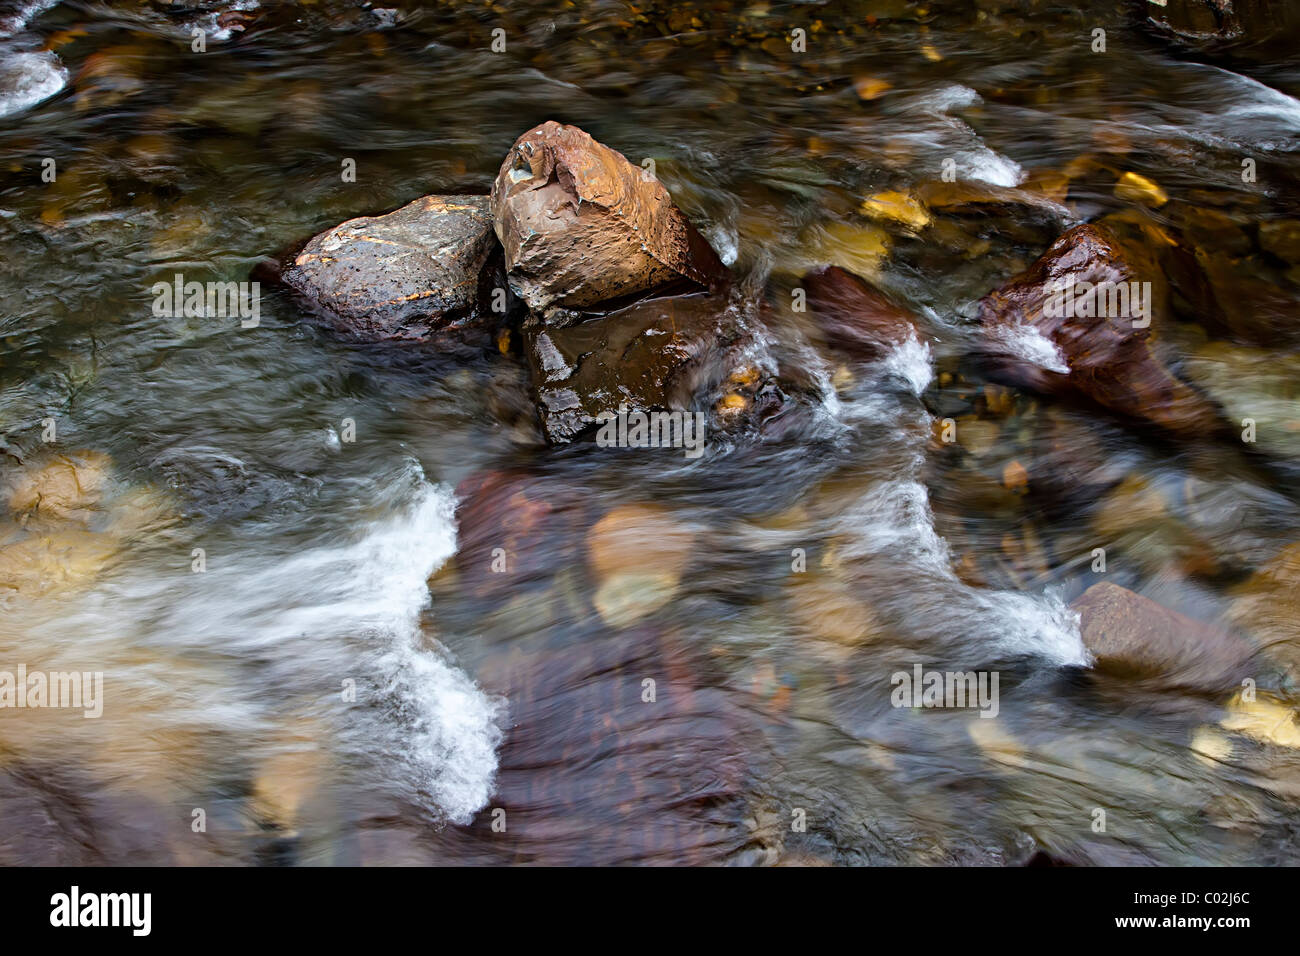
[803,265,918,360]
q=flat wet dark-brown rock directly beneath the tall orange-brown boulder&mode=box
[524,294,738,442]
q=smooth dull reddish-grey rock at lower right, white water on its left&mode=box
[1071,581,1255,693]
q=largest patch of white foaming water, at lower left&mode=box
[41,460,504,823]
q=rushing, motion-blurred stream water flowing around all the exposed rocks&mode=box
[0,0,1300,864]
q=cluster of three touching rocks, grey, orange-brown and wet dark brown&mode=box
[280,122,832,444]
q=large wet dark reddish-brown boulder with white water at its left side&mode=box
[979,225,1221,436]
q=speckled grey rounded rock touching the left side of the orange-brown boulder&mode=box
[281,196,504,341]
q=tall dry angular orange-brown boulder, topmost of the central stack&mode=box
[491,122,727,313]
